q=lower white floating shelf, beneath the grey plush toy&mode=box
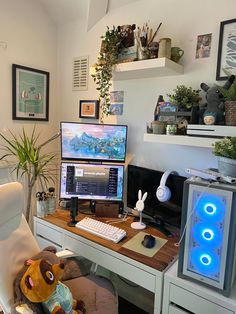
[143,133,219,148]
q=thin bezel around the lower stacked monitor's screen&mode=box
[59,160,125,202]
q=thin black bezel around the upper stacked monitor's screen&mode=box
[60,121,128,163]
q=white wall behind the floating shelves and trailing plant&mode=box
[58,0,236,174]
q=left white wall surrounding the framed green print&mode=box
[0,0,59,149]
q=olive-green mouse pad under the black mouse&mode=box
[122,231,168,257]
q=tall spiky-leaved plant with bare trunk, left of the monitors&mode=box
[0,127,59,222]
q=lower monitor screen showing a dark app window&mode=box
[60,162,124,201]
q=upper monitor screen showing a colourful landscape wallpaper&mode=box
[61,122,127,162]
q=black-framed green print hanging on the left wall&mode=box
[12,64,50,121]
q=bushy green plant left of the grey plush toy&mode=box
[167,85,201,111]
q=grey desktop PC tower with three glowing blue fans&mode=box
[178,178,236,296]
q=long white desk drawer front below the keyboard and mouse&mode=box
[64,235,157,292]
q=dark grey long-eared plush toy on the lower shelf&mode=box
[200,75,235,125]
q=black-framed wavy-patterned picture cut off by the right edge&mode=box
[216,19,236,81]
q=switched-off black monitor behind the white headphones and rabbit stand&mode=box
[127,165,186,228]
